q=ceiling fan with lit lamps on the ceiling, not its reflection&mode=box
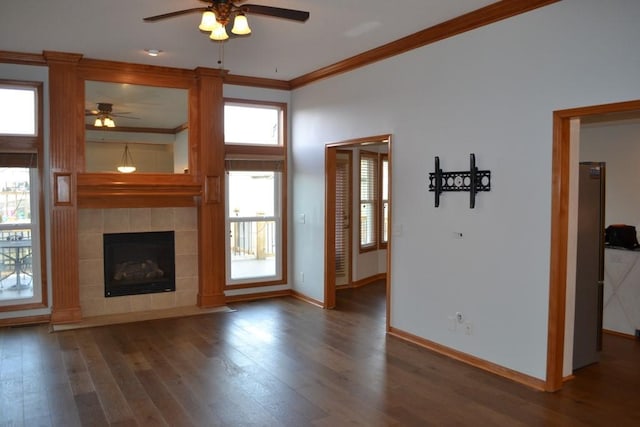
[144,0,309,41]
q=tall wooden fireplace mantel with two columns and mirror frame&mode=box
[44,51,226,324]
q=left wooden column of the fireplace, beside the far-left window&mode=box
[44,52,84,323]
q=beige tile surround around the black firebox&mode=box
[78,207,198,317]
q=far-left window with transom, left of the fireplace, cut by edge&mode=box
[0,81,46,311]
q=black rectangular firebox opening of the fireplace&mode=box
[103,231,176,297]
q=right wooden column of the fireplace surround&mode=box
[195,68,227,307]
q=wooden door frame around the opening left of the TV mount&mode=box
[323,134,393,331]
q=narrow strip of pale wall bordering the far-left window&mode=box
[0,63,52,319]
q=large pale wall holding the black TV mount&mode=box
[292,0,640,379]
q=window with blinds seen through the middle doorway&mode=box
[360,151,389,252]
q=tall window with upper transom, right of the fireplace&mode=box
[224,100,287,288]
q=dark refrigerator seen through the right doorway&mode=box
[573,162,605,370]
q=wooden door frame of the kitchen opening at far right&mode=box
[545,100,640,391]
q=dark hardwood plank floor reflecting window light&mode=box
[0,283,640,427]
